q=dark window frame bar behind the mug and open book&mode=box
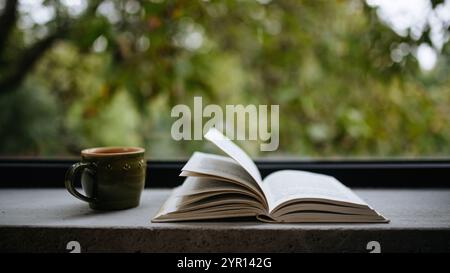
[0,158,450,188]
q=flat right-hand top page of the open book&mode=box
[263,170,367,211]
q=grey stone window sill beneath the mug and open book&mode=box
[0,189,450,252]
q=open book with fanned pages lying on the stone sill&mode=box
[152,128,389,223]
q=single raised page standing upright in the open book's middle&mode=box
[205,127,262,184]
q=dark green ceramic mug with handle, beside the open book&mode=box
[65,147,146,210]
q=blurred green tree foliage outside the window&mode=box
[0,0,450,158]
